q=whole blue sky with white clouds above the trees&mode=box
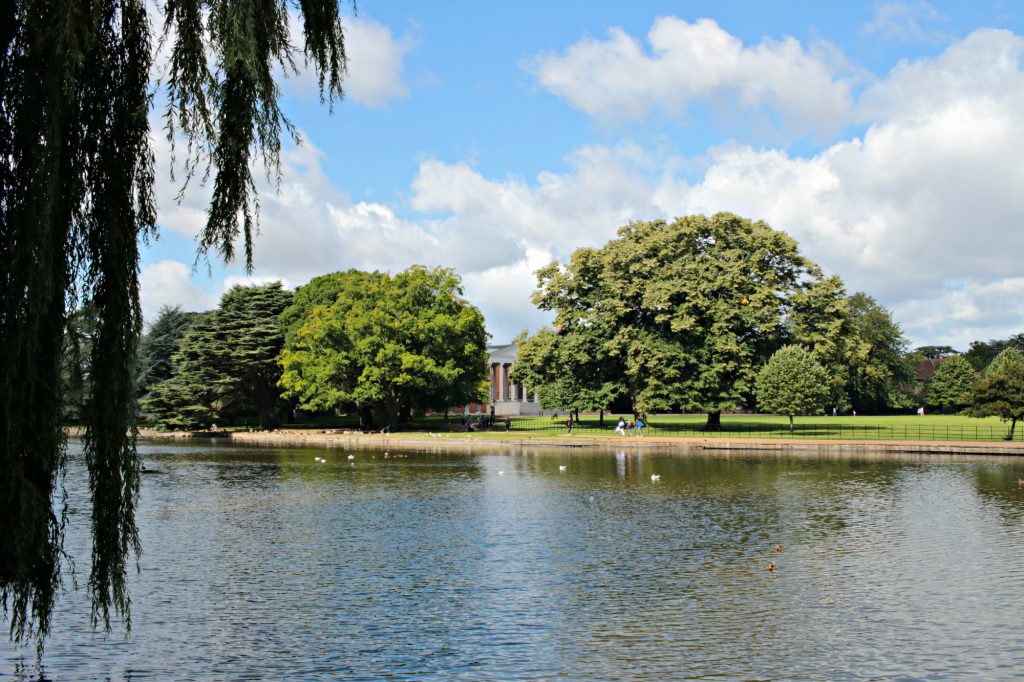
[142,0,1024,349]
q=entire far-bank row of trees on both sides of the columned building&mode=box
[63,213,1024,438]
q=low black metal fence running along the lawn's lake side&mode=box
[479,417,1024,441]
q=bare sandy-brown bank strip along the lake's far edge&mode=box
[112,429,1024,457]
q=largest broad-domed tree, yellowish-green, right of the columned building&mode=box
[534,213,820,428]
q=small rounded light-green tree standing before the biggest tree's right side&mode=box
[757,345,829,431]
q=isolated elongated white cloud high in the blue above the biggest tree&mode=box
[532,16,852,134]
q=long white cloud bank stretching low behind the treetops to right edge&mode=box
[143,19,1024,349]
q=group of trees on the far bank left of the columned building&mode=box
[99,266,486,430]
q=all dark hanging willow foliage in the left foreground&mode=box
[0,0,345,643]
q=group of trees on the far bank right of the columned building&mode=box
[512,213,1024,436]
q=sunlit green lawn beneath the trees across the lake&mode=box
[276,415,1024,440]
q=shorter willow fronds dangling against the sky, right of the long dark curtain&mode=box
[163,0,347,271]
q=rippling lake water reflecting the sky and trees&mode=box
[0,443,1024,680]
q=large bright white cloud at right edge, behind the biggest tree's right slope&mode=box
[657,31,1024,348]
